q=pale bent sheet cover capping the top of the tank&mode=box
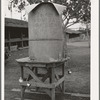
[26,2,66,14]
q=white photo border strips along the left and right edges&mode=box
[1,0,99,100]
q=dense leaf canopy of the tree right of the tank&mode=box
[63,0,91,27]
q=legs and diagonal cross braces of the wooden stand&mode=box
[20,64,64,100]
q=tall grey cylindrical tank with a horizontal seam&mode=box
[28,3,63,62]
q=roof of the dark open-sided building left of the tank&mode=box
[5,18,28,28]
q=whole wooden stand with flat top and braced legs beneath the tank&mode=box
[17,57,69,100]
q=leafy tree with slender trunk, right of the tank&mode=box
[54,0,91,57]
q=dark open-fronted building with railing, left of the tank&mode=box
[5,18,28,50]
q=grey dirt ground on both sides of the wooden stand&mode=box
[5,42,90,100]
